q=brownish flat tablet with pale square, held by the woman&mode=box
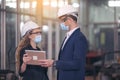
[25,50,46,65]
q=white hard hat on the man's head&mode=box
[58,5,78,17]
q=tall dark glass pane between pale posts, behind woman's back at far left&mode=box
[6,13,17,70]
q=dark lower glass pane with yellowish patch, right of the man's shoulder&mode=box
[89,24,114,51]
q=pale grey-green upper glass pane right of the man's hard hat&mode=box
[88,0,114,23]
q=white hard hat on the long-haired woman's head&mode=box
[21,21,39,37]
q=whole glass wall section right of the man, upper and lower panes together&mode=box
[87,0,120,52]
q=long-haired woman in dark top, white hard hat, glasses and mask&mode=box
[16,21,48,80]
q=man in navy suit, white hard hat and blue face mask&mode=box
[40,5,88,80]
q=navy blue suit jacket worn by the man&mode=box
[56,28,88,80]
